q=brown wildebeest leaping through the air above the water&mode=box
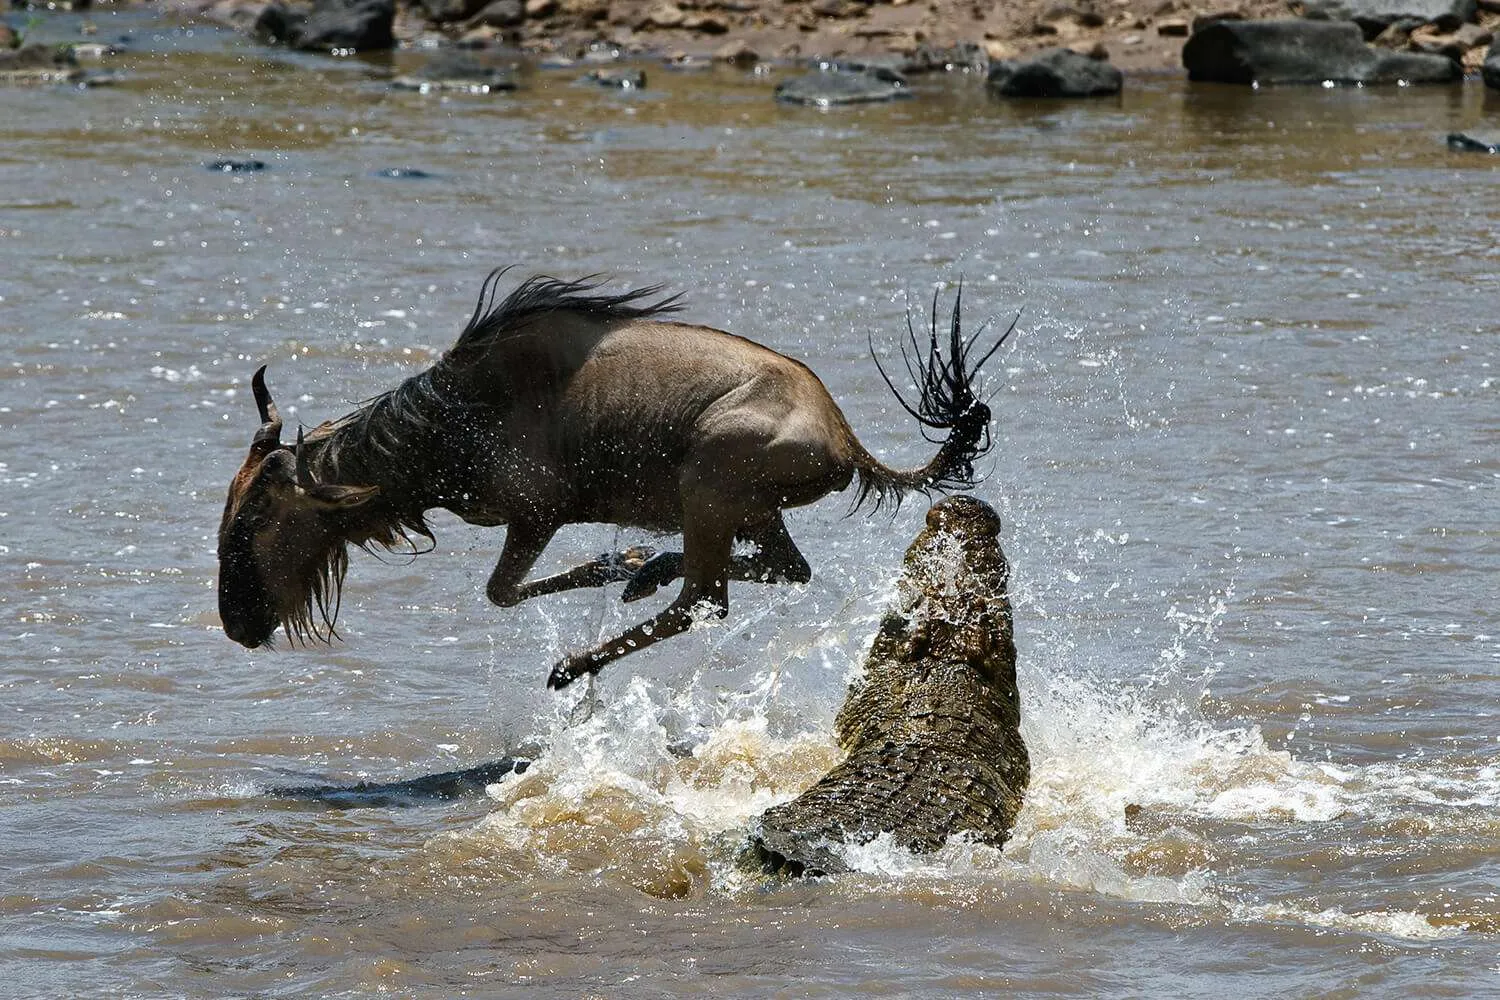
[219,268,1016,688]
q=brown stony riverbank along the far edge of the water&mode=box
[0,0,1500,73]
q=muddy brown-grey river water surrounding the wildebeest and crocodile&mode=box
[0,12,1500,997]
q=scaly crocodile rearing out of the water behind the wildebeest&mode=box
[750,496,1031,876]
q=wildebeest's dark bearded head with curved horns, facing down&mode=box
[219,366,378,649]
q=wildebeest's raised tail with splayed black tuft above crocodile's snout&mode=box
[851,282,1020,510]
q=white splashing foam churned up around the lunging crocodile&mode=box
[459,560,1500,940]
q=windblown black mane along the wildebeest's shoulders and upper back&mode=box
[441,267,683,366]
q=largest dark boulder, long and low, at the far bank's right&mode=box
[1182,19,1463,84]
